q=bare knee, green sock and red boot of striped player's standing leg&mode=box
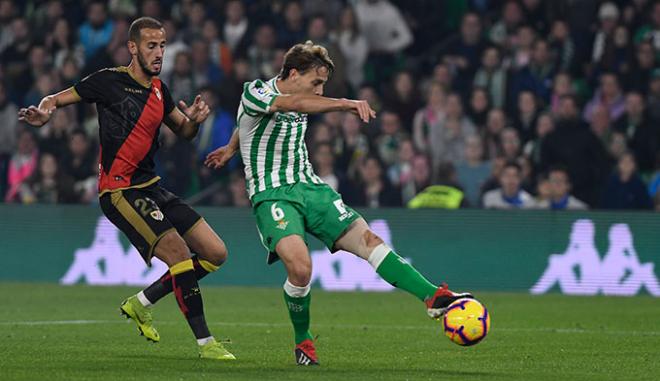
[275,235,318,365]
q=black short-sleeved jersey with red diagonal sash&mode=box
[73,66,174,194]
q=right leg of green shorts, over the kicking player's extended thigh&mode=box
[305,185,362,252]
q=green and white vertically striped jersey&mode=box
[236,77,323,198]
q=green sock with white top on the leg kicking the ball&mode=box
[369,245,438,301]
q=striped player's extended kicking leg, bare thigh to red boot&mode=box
[335,218,472,318]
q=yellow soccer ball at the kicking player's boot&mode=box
[442,298,490,346]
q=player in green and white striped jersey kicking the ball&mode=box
[206,41,472,365]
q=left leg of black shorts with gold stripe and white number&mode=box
[99,189,176,265]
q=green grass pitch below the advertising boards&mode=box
[0,283,660,381]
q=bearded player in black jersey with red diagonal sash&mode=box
[18,17,234,360]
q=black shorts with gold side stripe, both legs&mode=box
[99,184,202,266]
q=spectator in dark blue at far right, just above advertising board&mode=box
[603,152,653,209]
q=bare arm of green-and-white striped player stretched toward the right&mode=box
[270,94,376,123]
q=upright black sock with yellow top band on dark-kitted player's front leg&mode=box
[170,259,211,339]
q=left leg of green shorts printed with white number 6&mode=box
[253,200,305,263]
